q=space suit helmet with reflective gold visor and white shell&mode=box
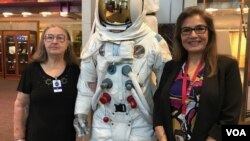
[98,0,143,30]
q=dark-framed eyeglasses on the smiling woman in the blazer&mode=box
[181,25,207,35]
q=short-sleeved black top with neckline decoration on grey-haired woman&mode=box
[17,62,80,141]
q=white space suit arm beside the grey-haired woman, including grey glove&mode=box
[74,57,97,137]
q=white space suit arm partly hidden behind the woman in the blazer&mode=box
[153,34,172,85]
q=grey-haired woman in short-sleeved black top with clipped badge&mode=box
[14,25,80,141]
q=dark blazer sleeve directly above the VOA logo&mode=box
[209,58,243,140]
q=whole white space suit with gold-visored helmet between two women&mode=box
[74,0,171,141]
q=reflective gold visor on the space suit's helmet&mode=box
[98,0,131,25]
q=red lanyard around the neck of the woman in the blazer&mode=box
[181,61,203,114]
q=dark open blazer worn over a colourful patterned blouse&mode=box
[153,56,242,141]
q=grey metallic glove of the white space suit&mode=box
[74,114,89,137]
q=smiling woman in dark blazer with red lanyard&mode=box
[153,7,242,141]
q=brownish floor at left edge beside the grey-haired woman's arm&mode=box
[0,78,18,141]
